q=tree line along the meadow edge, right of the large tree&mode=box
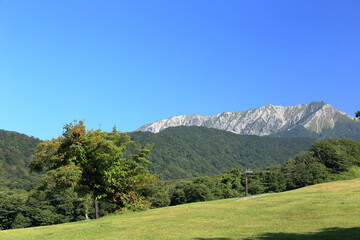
[144,139,360,207]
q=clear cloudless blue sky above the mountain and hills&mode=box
[0,0,360,139]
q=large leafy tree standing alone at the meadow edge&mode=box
[31,121,154,218]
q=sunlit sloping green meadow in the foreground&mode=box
[0,179,360,240]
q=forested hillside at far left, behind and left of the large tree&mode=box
[0,130,40,189]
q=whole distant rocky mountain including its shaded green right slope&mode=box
[136,102,360,139]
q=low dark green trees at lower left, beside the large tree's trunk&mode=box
[0,188,94,229]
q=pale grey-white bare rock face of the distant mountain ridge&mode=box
[136,102,355,136]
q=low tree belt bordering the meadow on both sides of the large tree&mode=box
[0,136,360,229]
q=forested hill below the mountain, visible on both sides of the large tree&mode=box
[0,126,314,185]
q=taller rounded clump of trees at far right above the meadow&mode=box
[282,139,360,189]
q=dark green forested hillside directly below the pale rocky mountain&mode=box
[130,126,314,179]
